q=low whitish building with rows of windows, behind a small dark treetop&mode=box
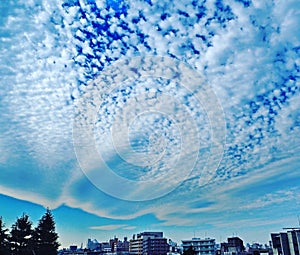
[181,237,216,255]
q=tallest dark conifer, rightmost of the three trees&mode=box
[34,209,60,255]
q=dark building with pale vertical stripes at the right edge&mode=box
[271,228,300,255]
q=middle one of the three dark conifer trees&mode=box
[10,213,33,255]
